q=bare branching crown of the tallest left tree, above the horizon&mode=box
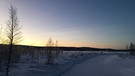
[6,5,22,44]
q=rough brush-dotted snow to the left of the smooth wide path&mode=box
[0,51,94,76]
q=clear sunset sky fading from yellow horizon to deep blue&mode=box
[0,0,135,49]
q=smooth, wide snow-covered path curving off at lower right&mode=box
[61,55,135,76]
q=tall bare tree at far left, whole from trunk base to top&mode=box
[6,5,21,76]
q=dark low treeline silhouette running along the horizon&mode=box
[0,44,130,52]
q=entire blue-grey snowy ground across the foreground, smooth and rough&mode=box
[0,51,135,76]
